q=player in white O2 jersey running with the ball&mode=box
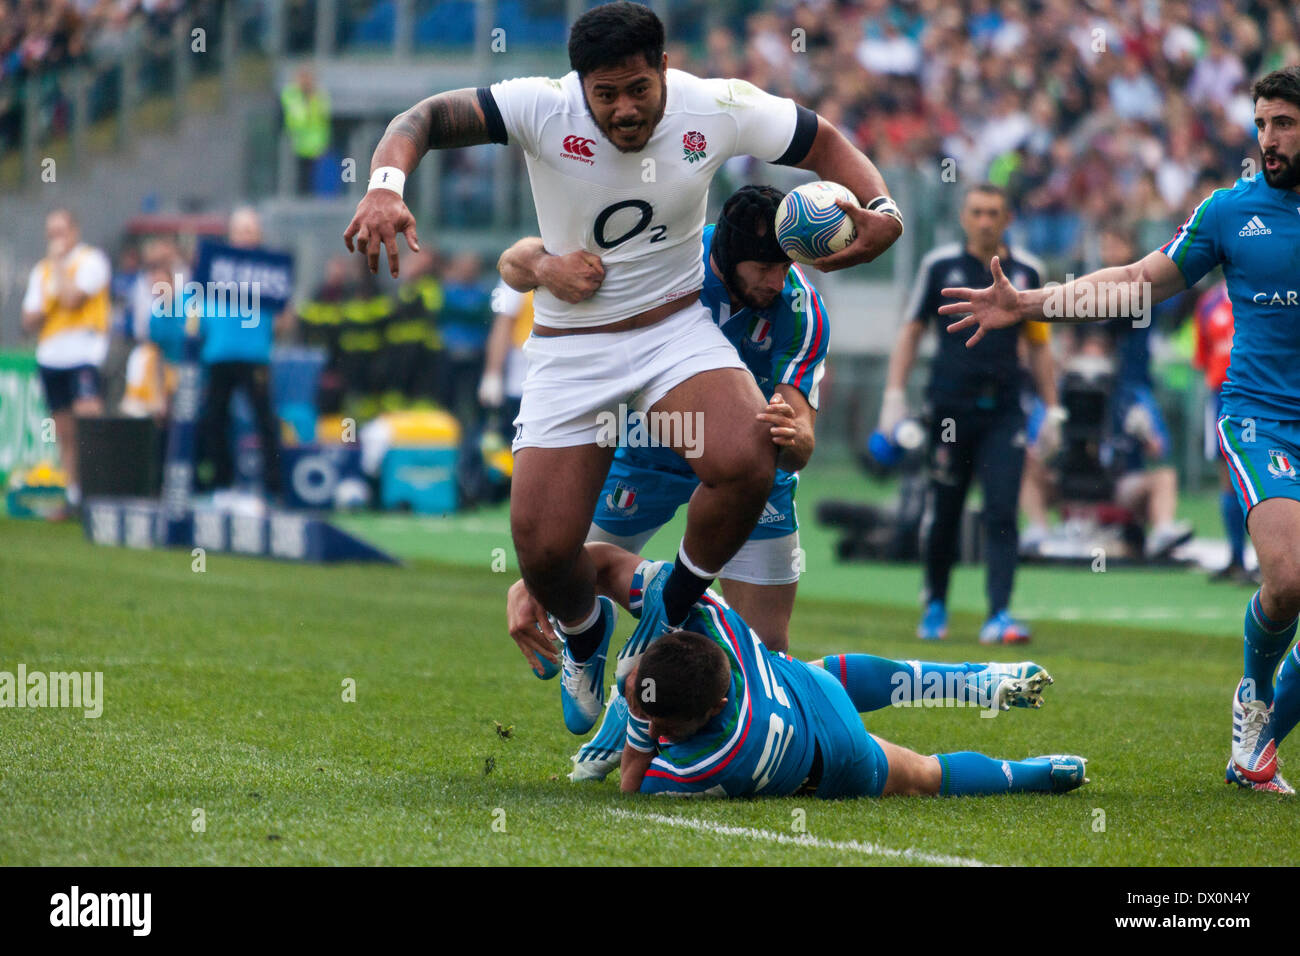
[343,0,902,734]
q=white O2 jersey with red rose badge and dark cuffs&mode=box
[478,70,816,328]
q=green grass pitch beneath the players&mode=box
[0,476,1300,865]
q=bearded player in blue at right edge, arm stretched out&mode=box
[939,66,1300,793]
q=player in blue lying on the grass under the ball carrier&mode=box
[511,542,1087,799]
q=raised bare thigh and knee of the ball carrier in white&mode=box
[650,368,776,485]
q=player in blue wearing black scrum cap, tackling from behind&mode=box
[502,186,829,779]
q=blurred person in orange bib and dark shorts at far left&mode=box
[22,209,112,507]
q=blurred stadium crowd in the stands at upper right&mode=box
[671,0,1300,261]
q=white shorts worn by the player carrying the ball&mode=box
[512,302,745,451]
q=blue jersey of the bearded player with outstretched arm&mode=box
[1160,174,1300,421]
